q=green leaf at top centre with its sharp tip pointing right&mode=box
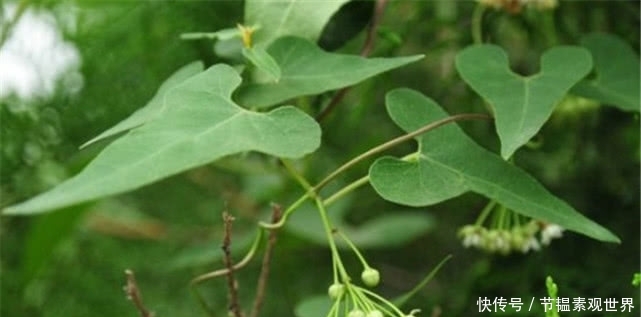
[238,37,422,107]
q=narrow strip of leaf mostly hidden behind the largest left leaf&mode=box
[80,62,205,148]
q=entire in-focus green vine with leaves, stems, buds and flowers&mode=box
[4,1,639,316]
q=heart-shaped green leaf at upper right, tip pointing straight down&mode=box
[456,45,592,159]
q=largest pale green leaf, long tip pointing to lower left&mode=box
[4,65,321,214]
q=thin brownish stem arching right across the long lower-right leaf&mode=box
[313,113,491,193]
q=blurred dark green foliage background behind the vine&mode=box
[0,0,641,317]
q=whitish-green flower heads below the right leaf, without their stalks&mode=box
[458,220,563,255]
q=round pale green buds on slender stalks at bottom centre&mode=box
[327,232,420,317]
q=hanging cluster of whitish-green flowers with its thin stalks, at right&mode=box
[458,202,563,255]
